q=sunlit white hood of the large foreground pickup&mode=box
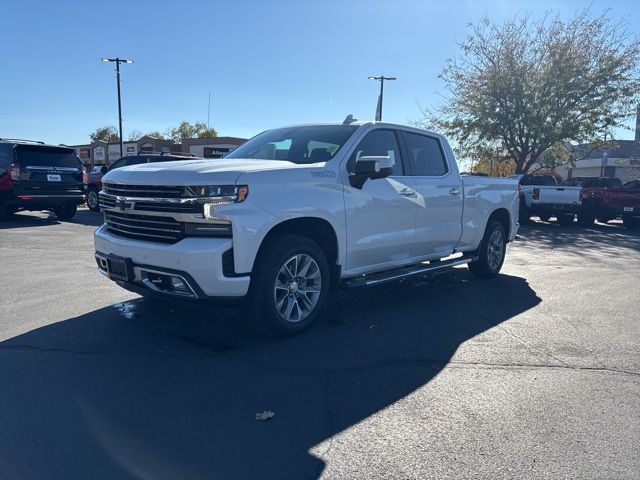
[102,158,309,185]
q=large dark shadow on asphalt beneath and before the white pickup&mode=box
[0,269,541,479]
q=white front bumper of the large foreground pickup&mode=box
[94,225,250,300]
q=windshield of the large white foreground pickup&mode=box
[225,125,358,163]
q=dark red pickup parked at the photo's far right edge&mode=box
[563,177,640,228]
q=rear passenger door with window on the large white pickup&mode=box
[403,131,463,257]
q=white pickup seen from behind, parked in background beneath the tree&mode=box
[514,175,582,225]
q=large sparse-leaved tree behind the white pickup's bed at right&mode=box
[423,9,640,173]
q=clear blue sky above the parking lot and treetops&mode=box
[0,0,640,144]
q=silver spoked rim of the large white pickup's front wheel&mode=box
[273,253,322,323]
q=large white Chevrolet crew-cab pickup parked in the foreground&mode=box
[94,120,518,335]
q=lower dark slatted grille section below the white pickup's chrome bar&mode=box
[104,210,184,243]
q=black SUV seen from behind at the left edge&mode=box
[0,138,86,220]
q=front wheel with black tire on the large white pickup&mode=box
[247,234,330,337]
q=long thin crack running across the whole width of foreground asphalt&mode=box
[0,344,640,380]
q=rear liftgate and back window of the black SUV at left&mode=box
[14,144,83,196]
